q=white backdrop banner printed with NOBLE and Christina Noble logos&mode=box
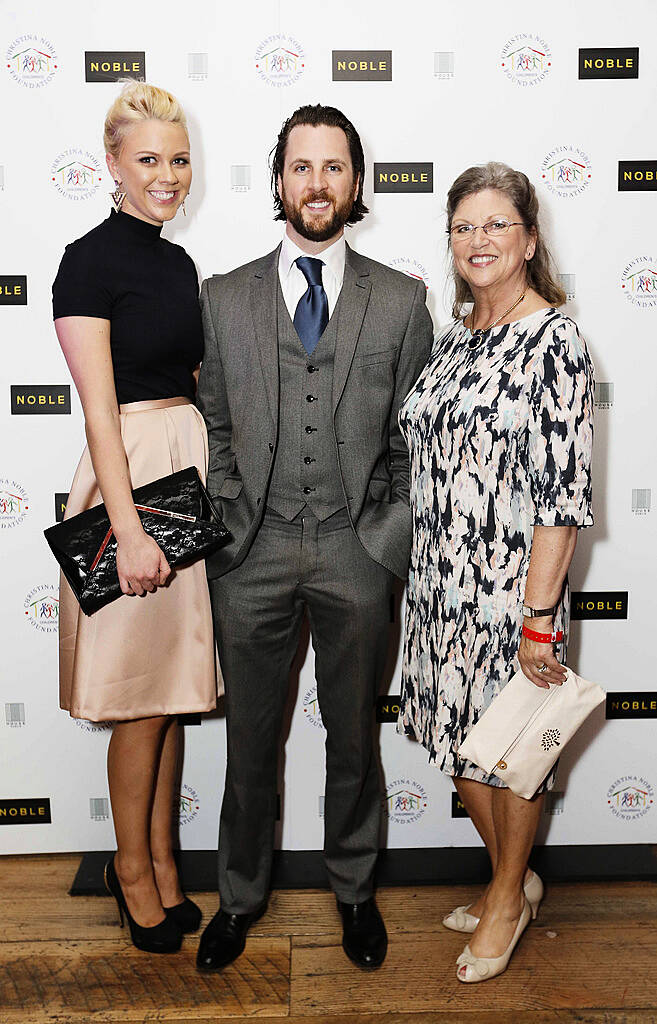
[0,0,657,853]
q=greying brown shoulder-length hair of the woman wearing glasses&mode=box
[447,161,566,318]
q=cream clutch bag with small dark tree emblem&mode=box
[458,669,606,800]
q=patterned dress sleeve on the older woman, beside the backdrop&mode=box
[529,317,594,526]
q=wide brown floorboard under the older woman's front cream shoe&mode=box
[291,925,657,1019]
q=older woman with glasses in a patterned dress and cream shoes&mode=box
[400,163,593,982]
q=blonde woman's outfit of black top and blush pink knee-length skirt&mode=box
[52,207,221,722]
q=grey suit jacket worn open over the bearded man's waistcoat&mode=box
[199,235,433,579]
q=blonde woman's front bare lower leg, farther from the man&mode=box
[107,716,170,928]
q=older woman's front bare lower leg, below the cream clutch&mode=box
[462,786,543,956]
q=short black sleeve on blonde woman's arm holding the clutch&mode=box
[52,242,113,319]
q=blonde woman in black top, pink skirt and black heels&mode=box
[53,82,217,952]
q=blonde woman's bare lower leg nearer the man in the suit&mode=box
[150,718,183,906]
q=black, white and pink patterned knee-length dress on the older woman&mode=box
[398,308,594,788]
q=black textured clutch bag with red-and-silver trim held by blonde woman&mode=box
[44,466,230,615]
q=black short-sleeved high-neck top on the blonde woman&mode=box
[52,211,203,404]
